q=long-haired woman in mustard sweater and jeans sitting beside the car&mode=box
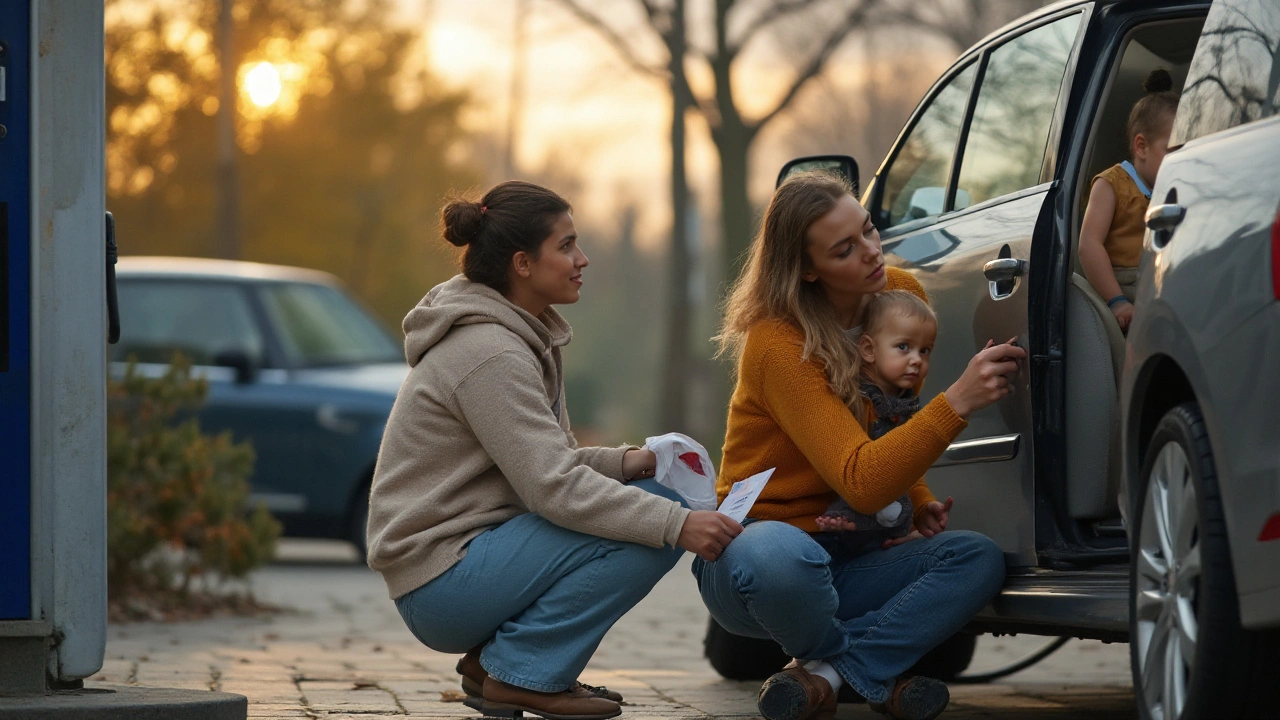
[692,173,1025,720]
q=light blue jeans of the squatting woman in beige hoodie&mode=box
[396,479,684,692]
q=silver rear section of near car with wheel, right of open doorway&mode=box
[1121,0,1280,717]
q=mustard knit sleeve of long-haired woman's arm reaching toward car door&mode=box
[759,341,966,515]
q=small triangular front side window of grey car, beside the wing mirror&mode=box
[876,63,977,228]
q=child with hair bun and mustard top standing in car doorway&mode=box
[1080,68,1178,333]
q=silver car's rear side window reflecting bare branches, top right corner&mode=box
[1169,0,1280,147]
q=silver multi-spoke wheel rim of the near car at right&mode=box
[1134,442,1201,720]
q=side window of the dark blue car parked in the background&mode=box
[111,279,262,365]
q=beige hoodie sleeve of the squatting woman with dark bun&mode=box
[453,351,689,547]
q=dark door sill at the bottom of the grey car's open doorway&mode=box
[970,566,1129,642]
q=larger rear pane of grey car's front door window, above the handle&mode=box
[955,14,1080,209]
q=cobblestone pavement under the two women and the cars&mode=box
[87,541,1135,720]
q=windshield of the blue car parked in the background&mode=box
[261,283,404,368]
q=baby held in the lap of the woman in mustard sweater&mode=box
[814,290,951,553]
